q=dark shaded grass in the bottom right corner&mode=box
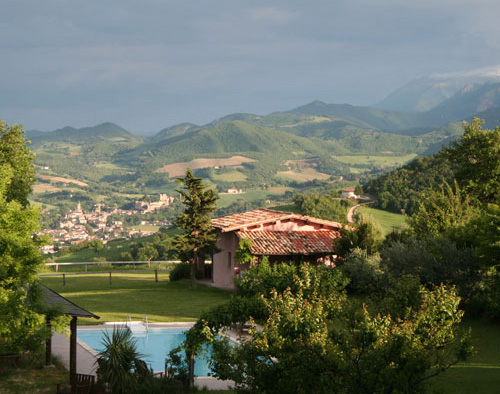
[432,319,500,394]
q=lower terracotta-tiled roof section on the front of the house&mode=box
[235,230,339,256]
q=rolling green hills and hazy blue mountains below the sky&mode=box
[27,70,500,208]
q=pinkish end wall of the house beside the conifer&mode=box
[213,232,238,289]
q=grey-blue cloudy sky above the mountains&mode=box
[0,0,500,134]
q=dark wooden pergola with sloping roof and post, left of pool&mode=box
[41,285,100,392]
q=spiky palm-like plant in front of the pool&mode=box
[97,328,150,394]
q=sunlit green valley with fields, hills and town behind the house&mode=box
[27,77,500,254]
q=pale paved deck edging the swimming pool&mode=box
[52,323,234,390]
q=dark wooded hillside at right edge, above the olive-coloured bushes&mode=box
[364,119,500,215]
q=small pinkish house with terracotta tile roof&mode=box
[212,209,342,288]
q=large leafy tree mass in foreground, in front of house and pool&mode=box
[186,264,471,394]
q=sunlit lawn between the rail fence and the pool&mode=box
[42,271,230,324]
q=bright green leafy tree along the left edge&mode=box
[0,123,48,353]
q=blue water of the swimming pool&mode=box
[78,328,210,376]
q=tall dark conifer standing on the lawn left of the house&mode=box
[174,169,219,285]
